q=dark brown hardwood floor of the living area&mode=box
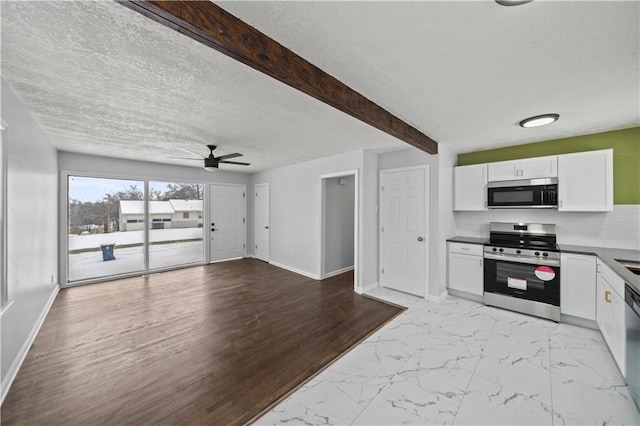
[1,259,402,425]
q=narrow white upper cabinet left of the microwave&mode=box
[453,164,487,211]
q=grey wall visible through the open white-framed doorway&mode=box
[323,175,356,274]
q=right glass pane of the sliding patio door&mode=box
[149,181,204,269]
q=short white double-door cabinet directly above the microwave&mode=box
[488,155,558,182]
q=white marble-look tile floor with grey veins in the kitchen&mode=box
[255,288,640,425]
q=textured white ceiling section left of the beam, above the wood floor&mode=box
[2,1,406,172]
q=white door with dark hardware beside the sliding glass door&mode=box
[209,185,245,262]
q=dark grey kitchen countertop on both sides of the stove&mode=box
[447,235,640,293]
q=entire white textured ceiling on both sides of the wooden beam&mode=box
[1,0,640,172]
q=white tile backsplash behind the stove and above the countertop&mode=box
[454,204,640,250]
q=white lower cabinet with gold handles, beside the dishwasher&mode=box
[596,260,627,376]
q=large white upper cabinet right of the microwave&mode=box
[558,149,613,212]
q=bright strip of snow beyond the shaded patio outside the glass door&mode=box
[69,228,203,251]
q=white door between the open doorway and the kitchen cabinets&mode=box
[380,168,427,296]
